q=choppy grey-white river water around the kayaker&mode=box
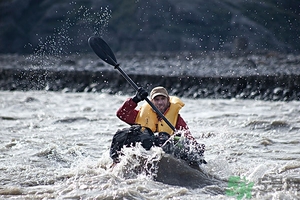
[0,91,300,199]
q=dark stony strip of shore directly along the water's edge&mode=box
[0,68,300,101]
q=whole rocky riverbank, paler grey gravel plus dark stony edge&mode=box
[0,52,300,101]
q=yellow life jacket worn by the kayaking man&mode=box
[135,96,184,135]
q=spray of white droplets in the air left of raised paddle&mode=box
[18,3,111,90]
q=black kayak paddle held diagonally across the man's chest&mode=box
[88,36,176,132]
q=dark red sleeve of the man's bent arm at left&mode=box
[117,98,138,125]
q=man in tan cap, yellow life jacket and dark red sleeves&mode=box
[117,86,196,141]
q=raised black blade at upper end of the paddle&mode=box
[88,36,118,66]
